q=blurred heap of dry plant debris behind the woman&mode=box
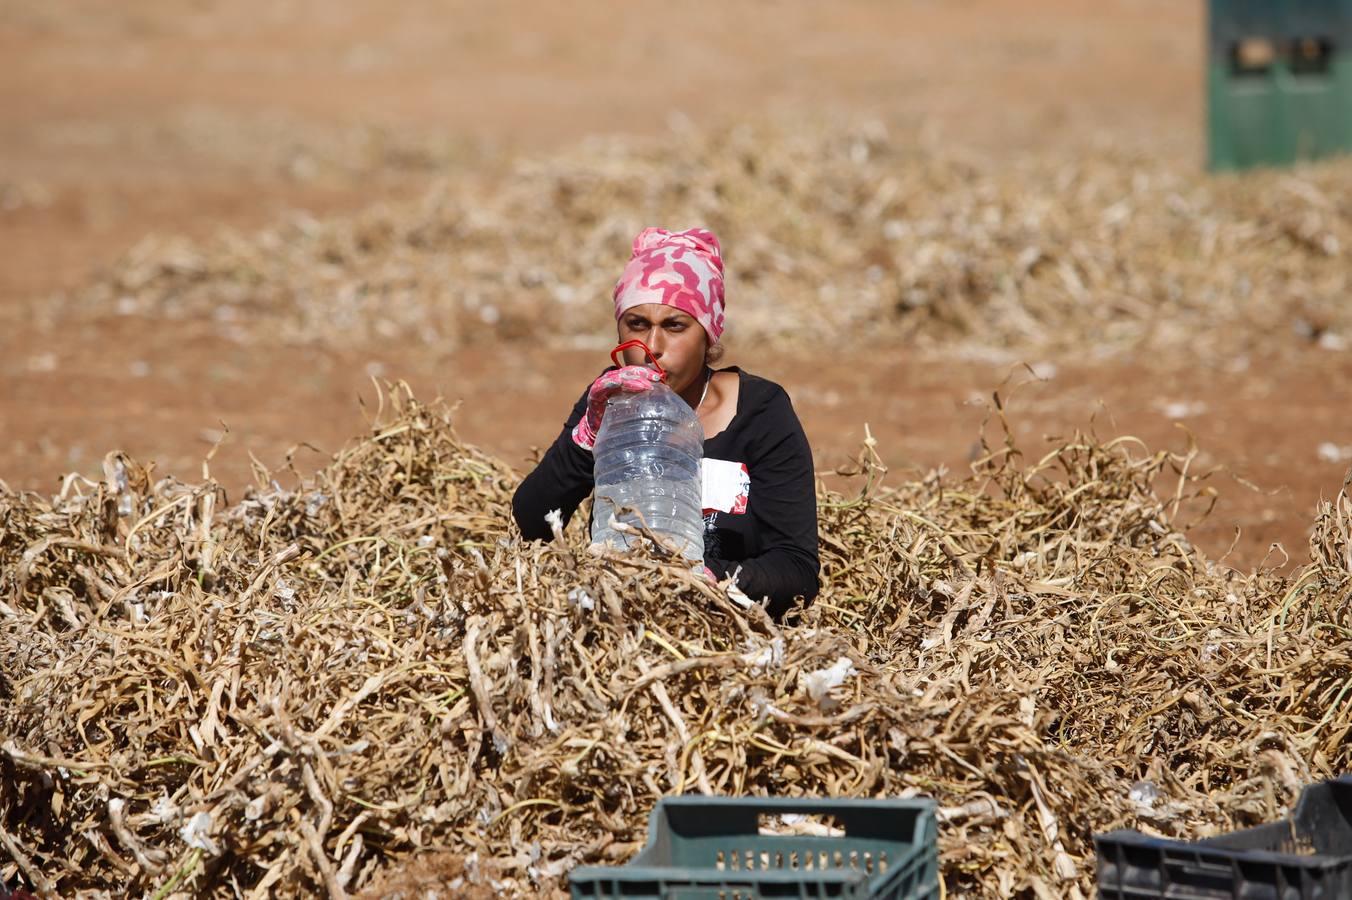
[41,122,1352,358]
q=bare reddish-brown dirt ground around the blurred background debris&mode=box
[0,0,1352,565]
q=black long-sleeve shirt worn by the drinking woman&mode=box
[512,366,821,616]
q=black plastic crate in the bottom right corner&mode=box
[1094,776,1352,900]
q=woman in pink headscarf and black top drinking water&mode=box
[512,228,821,618]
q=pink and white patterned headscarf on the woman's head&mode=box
[615,228,725,343]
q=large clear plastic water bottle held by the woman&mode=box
[592,370,704,565]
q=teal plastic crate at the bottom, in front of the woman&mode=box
[569,796,940,900]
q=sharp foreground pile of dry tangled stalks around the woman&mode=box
[0,389,1352,897]
